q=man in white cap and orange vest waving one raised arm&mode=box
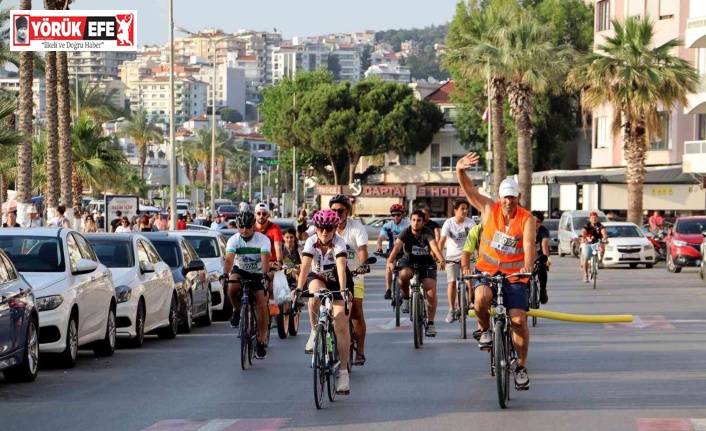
[456,153,536,390]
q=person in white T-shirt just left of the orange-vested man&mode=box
[439,198,476,323]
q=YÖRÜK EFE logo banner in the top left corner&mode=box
[10,10,137,51]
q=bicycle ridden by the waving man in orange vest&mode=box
[463,272,532,409]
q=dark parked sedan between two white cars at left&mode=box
[143,232,213,333]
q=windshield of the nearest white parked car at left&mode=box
[0,235,64,272]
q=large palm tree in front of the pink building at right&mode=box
[567,17,699,225]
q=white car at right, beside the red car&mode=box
[603,222,656,268]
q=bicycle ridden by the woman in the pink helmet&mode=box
[295,288,349,409]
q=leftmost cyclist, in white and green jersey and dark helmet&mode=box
[223,211,270,359]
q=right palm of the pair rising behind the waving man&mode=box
[501,11,574,208]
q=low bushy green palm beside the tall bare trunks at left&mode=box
[71,114,127,206]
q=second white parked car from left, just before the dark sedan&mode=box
[86,233,179,347]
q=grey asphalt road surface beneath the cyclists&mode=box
[0,256,706,431]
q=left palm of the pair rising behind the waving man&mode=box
[442,1,518,188]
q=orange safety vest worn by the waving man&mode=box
[476,202,532,274]
